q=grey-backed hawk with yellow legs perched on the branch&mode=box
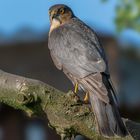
[48,4,128,137]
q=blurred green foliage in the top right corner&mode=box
[102,0,140,32]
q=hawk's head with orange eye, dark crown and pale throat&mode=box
[49,4,74,30]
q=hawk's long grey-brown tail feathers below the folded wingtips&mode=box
[89,93,127,137]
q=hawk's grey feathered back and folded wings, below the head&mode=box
[49,19,107,78]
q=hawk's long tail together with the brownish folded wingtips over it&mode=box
[82,74,128,137]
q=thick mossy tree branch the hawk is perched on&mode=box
[0,71,137,140]
